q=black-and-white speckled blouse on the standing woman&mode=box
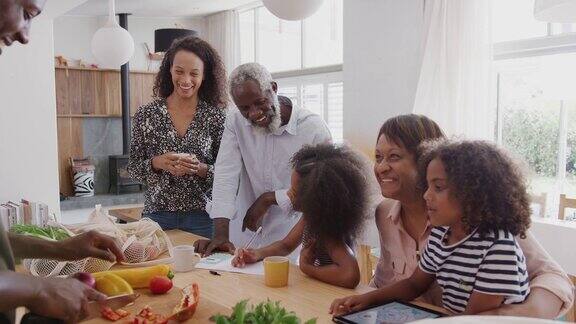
[128,98,226,213]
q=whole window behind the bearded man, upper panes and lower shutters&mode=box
[240,0,344,143]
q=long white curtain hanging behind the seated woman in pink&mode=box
[413,0,496,140]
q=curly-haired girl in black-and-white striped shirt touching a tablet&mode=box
[331,141,530,314]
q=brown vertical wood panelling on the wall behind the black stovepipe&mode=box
[55,67,156,196]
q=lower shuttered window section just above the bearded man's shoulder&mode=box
[276,72,344,143]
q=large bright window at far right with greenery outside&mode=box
[493,0,576,220]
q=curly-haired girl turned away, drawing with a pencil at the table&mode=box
[232,144,367,288]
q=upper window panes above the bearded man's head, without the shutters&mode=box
[240,0,344,72]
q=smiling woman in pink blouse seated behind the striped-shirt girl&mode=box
[331,115,574,318]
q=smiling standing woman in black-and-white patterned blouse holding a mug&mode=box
[128,37,228,238]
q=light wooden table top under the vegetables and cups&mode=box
[84,230,440,323]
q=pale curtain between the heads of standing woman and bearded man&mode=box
[206,10,240,73]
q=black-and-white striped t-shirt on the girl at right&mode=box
[419,227,530,313]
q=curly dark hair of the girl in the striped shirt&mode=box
[419,140,530,238]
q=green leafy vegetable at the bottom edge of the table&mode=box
[211,299,316,324]
